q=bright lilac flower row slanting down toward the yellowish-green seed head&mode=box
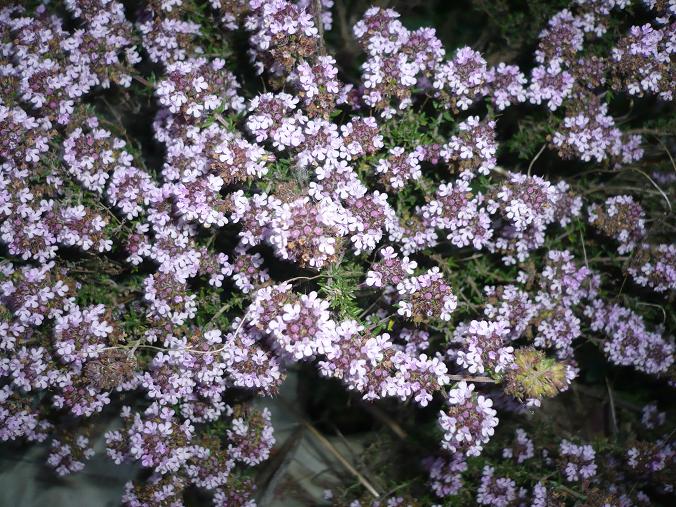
[244,284,449,406]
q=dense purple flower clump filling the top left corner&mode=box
[0,0,140,125]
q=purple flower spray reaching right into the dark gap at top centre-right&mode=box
[354,7,526,118]
